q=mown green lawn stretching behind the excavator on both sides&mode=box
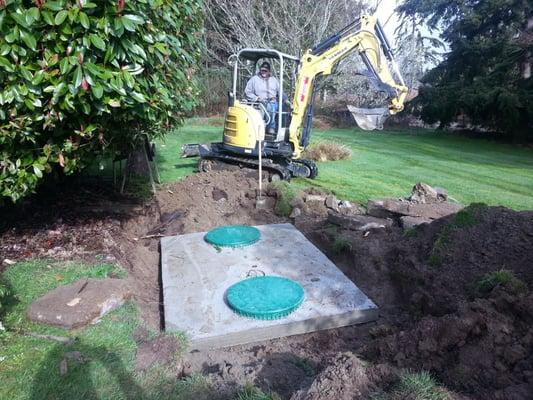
[158,120,533,210]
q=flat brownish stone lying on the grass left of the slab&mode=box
[26,279,131,329]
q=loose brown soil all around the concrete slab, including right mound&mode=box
[0,171,533,400]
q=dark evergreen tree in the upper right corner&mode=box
[398,0,533,141]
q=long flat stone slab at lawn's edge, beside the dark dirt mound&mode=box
[367,199,463,219]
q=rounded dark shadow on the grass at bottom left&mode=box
[29,343,145,400]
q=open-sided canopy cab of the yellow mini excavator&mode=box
[224,48,300,146]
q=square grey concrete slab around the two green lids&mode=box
[161,224,378,350]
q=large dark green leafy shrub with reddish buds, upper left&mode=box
[0,0,202,201]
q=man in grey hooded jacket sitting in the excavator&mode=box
[244,61,279,134]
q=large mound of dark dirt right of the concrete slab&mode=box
[310,205,533,399]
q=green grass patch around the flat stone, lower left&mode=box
[0,260,212,400]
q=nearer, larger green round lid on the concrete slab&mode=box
[226,276,304,319]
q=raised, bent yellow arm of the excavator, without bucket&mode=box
[289,15,407,158]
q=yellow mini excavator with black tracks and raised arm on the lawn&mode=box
[183,15,407,180]
